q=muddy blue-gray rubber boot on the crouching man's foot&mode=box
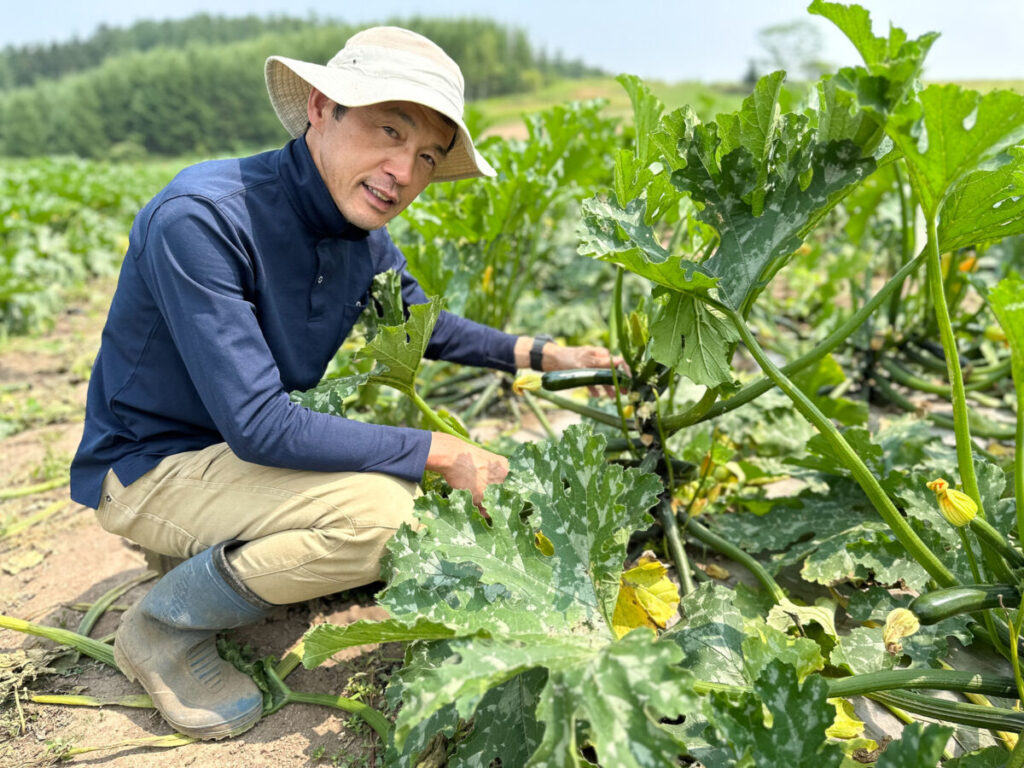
[114,543,272,738]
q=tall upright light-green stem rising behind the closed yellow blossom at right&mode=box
[926,219,985,518]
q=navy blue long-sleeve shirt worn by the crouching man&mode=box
[71,138,515,507]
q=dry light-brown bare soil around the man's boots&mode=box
[0,284,401,768]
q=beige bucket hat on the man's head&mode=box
[265,27,496,181]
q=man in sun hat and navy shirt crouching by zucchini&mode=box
[72,27,610,738]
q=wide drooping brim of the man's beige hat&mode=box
[265,56,497,181]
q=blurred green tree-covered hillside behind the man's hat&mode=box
[0,14,599,159]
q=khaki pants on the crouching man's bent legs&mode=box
[96,443,420,604]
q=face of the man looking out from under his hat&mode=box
[306,89,456,229]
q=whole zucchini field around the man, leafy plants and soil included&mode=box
[0,2,1024,768]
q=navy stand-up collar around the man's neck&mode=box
[279,136,370,240]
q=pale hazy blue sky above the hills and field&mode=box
[8,0,1024,81]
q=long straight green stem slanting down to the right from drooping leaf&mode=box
[720,306,956,587]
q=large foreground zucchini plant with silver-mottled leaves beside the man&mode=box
[305,0,1024,768]
